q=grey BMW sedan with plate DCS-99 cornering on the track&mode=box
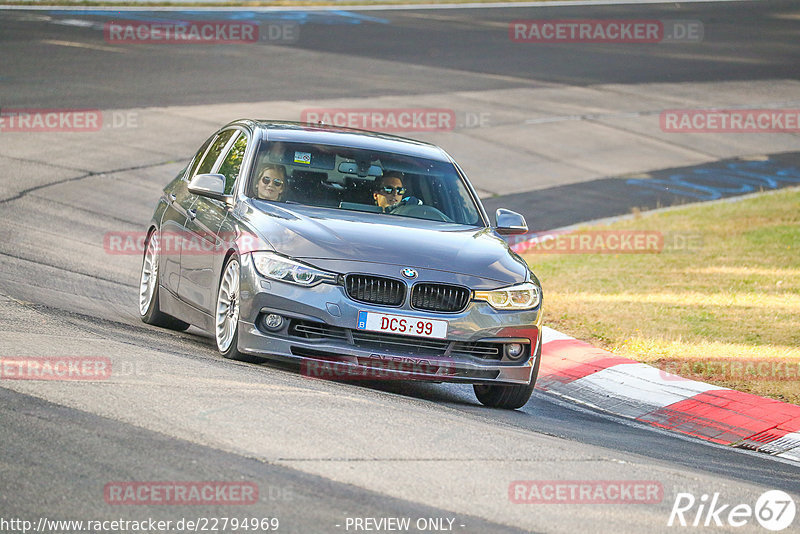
[139,120,542,409]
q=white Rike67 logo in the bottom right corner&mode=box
[667,490,797,532]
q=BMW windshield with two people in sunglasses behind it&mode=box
[247,142,484,226]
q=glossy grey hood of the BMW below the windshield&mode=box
[244,201,528,284]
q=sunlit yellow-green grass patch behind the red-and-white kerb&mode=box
[524,189,800,404]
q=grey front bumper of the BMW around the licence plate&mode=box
[238,254,541,385]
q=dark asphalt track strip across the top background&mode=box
[0,1,800,109]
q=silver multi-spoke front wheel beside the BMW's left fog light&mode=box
[214,255,261,363]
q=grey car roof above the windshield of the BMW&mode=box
[244,120,450,161]
